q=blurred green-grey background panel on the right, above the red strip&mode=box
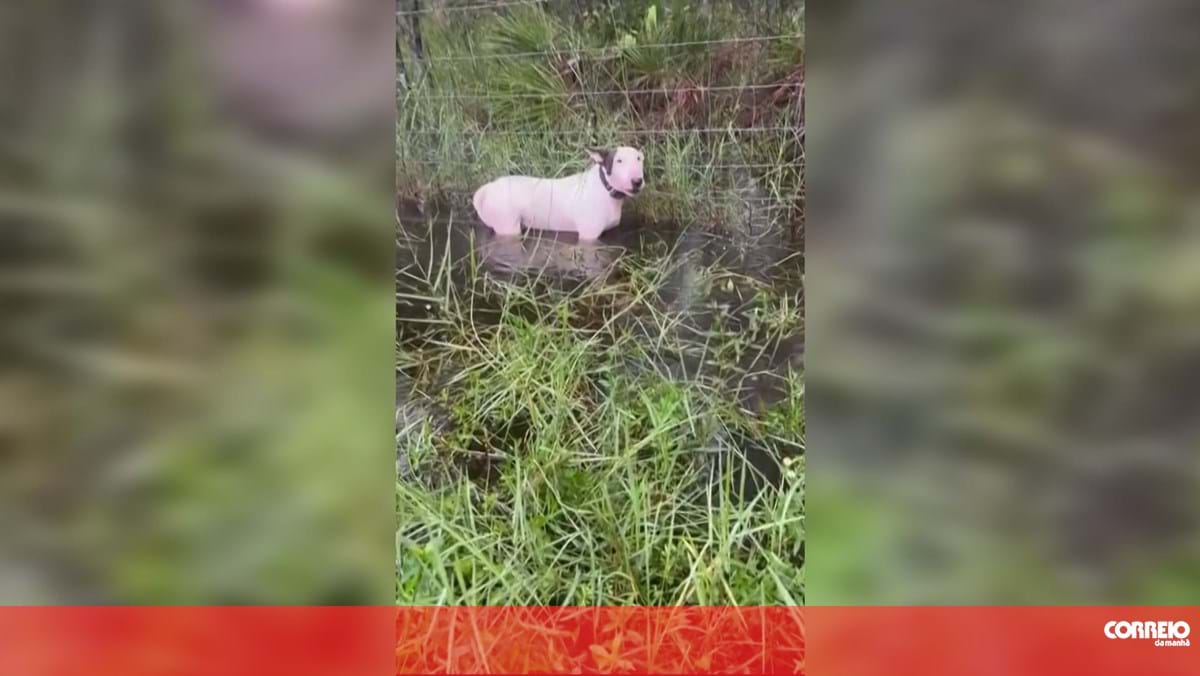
[808,0,1200,605]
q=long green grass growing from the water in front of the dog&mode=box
[396,223,804,605]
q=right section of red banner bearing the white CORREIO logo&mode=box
[805,606,1200,676]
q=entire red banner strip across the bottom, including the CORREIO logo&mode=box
[0,606,1200,676]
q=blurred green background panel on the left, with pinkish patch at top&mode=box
[0,0,394,604]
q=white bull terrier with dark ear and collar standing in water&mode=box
[474,145,644,241]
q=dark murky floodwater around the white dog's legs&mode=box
[396,198,804,496]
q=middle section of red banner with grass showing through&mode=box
[396,606,804,674]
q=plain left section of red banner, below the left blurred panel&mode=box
[0,606,396,676]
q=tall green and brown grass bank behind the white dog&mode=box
[397,1,804,226]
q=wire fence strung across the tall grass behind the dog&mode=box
[396,0,804,217]
